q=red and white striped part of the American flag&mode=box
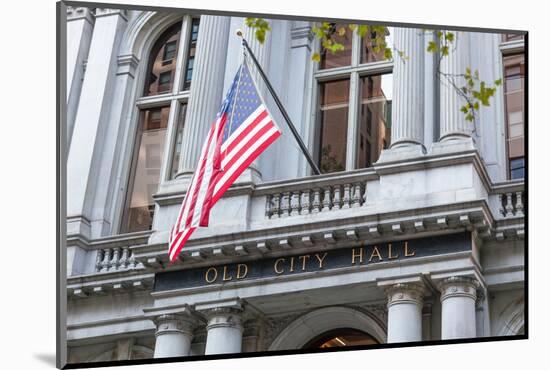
[169,104,281,262]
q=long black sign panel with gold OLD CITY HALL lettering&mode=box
[154,232,471,291]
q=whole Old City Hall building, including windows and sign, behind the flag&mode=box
[66,7,526,362]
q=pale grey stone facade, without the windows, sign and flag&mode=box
[67,8,526,362]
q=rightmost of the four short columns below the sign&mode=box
[439,277,479,339]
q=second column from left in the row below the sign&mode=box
[204,307,243,355]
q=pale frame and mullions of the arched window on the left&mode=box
[116,15,200,234]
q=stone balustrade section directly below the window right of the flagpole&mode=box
[265,181,366,218]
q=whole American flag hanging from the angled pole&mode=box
[168,61,281,262]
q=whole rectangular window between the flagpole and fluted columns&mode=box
[315,24,392,173]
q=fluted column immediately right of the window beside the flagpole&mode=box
[391,28,425,148]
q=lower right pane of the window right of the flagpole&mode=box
[357,74,393,168]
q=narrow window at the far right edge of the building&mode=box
[503,54,525,179]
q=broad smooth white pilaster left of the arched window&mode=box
[67,8,127,238]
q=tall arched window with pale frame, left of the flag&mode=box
[121,17,200,233]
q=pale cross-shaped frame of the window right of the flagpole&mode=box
[308,27,394,173]
